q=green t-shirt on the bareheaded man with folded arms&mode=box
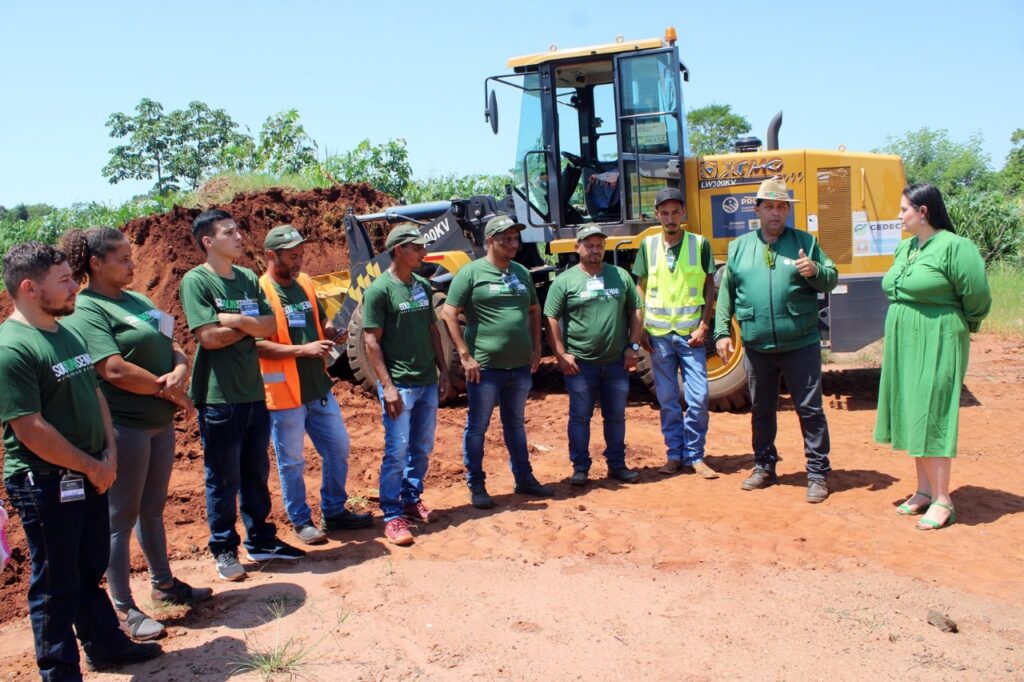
[179,265,273,404]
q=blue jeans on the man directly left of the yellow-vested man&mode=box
[564,358,630,471]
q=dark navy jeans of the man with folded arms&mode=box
[199,400,276,556]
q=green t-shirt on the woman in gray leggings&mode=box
[61,289,174,429]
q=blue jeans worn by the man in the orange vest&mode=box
[270,391,348,526]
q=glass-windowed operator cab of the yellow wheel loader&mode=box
[485,39,688,242]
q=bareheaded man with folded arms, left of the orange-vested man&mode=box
[179,209,305,581]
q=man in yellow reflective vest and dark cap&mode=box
[633,187,718,478]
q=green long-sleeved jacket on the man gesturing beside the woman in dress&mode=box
[715,227,839,353]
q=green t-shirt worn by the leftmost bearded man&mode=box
[0,319,104,478]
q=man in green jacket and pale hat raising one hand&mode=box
[715,177,838,503]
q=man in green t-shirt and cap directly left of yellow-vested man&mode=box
[544,223,643,485]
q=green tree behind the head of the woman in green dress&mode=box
[873,128,996,195]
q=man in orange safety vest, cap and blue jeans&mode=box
[256,225,373,545]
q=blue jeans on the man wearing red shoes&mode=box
[377,383,437,523]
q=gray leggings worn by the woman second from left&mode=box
[106,424,174,611]
